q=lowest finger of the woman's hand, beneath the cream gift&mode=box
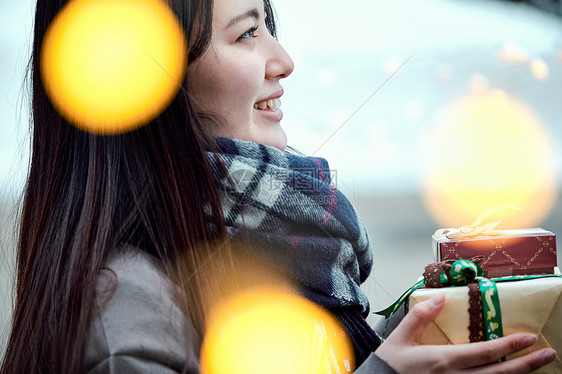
[472,348,556,374]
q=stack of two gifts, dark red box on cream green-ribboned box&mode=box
[379,226,562,374]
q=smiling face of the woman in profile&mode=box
[187,0,293,150]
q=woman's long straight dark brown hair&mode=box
[1,0,275,373]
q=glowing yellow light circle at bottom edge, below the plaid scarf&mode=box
[201,287,354,374]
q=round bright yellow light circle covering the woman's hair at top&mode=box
[41,0,187,134]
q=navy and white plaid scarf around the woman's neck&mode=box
[205,138,378,361]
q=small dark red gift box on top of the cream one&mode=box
[433,228,557,277]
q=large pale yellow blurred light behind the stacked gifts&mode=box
[423,90,557,228]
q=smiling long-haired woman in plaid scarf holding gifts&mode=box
[2,0,554,373]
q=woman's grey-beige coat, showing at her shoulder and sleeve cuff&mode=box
[86,247,395,374]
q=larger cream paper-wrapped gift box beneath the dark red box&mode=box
[409,277,562,374]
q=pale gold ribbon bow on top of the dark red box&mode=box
[434,203,521,240]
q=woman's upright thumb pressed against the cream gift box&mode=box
[389,293,445,343]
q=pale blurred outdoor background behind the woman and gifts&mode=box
[0,0,562,348]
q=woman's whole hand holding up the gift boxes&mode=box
[376,294,556,374]
